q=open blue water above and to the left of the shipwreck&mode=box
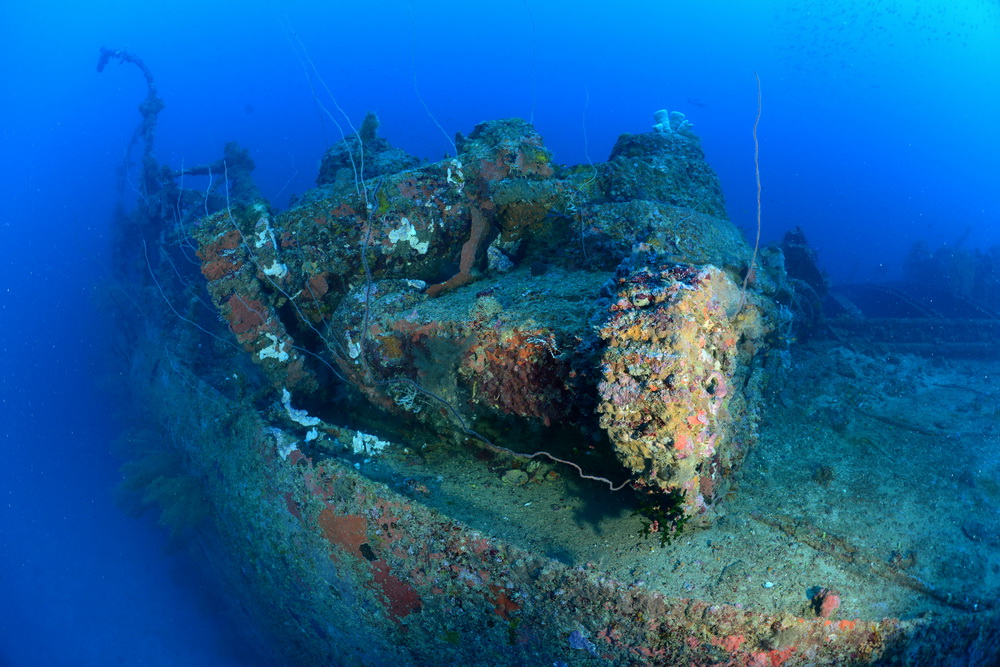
[0,0,1000,666]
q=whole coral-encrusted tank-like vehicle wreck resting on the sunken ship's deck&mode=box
[184,118,781,522]
